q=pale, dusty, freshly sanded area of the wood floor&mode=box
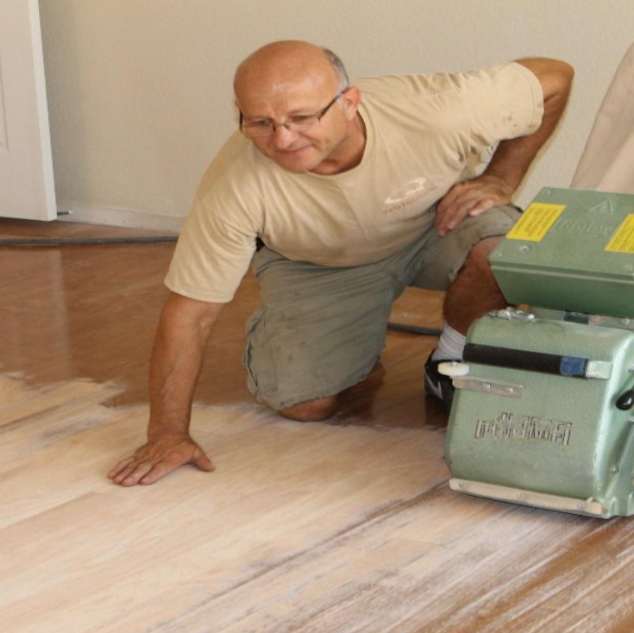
[0,376,634,633]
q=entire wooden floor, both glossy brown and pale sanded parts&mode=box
[0,220,634,633]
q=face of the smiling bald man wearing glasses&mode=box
[238,76,350,172]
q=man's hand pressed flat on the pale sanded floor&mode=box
[108,433,215,486]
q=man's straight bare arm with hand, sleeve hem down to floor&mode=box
[108,293,224,486]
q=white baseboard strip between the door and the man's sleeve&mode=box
[58,206,185,233]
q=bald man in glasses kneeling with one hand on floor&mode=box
[109,41,573,486]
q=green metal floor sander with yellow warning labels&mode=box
[441,189,634,518]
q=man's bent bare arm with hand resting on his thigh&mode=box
[436,59,574,235]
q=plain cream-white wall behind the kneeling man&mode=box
[40,0,634,228]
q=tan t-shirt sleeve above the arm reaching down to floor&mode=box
[165,198,256,303]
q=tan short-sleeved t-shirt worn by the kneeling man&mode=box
[165,63,543,303]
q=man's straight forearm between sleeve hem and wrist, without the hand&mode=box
[148,296,224,439]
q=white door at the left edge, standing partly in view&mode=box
[0,0,57,220]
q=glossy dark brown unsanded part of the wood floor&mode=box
[0,220,444,427]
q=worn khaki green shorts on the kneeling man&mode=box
[244,206,520,411]
